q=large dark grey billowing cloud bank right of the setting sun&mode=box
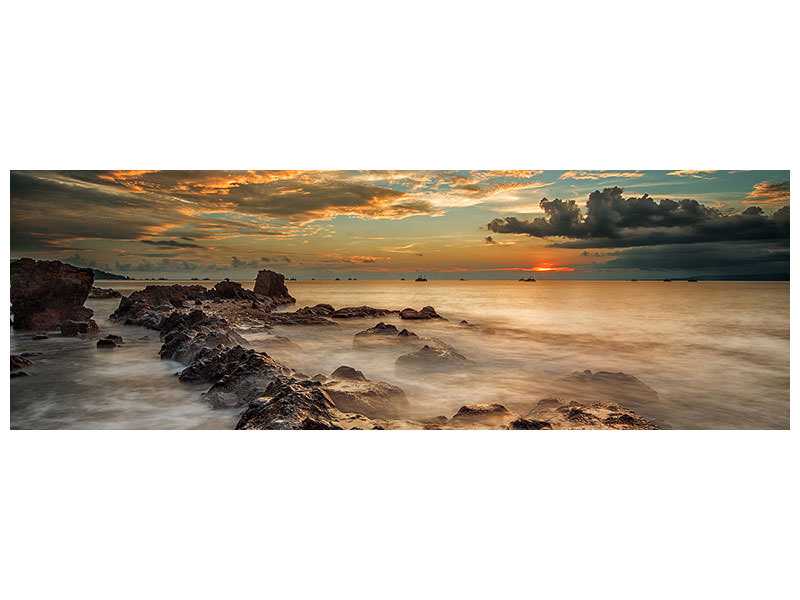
[488,187,789,248]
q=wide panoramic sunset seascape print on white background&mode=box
[9,169,790,430]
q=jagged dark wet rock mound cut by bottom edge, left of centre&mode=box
[231,377,342,429]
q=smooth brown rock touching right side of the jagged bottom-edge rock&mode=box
[323,366,408,418]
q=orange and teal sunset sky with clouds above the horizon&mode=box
[10,170,789,279]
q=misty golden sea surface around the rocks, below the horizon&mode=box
[11,280,789,429]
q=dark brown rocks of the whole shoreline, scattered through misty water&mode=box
[11,259,656,430]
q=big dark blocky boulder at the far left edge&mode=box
[11,258,94,330]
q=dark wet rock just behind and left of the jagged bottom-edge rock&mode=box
[203,350,291,407]
